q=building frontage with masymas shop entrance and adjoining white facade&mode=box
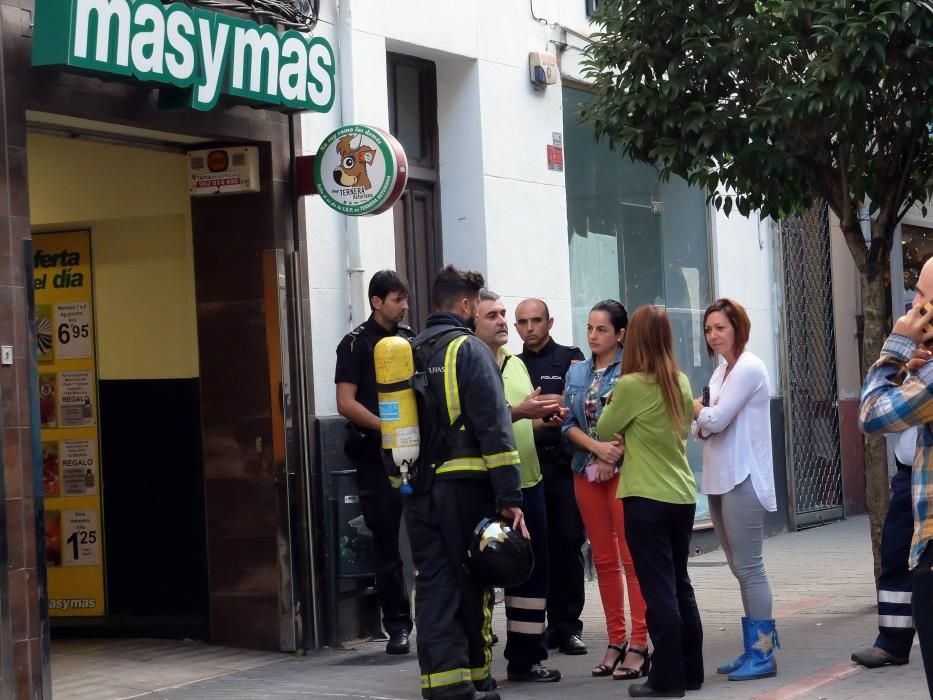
[0,0,787,697]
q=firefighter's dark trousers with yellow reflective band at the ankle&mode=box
[405,479,495,700]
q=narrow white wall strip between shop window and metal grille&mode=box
[712,210,782,396]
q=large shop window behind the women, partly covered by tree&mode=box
[563,87,714,518]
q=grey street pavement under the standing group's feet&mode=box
[102,516,928,700]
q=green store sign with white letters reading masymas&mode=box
[32,0,336,112]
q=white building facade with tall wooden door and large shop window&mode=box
[301,0,788,600]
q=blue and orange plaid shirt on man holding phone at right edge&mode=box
[859,334,933,569]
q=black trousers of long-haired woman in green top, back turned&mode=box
[622,497,703,690]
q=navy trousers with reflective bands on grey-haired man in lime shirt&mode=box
[505,484,549,671]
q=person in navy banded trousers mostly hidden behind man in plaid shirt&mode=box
[852,427,917,668]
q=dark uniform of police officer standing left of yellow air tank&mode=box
[334,316,414,636]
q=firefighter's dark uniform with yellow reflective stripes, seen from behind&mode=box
[405,313,522,700]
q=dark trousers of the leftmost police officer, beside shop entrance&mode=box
[356,462,412,635]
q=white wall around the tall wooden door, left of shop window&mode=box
[301,0,585,415]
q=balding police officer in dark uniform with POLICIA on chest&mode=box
[515,299,586,655]
